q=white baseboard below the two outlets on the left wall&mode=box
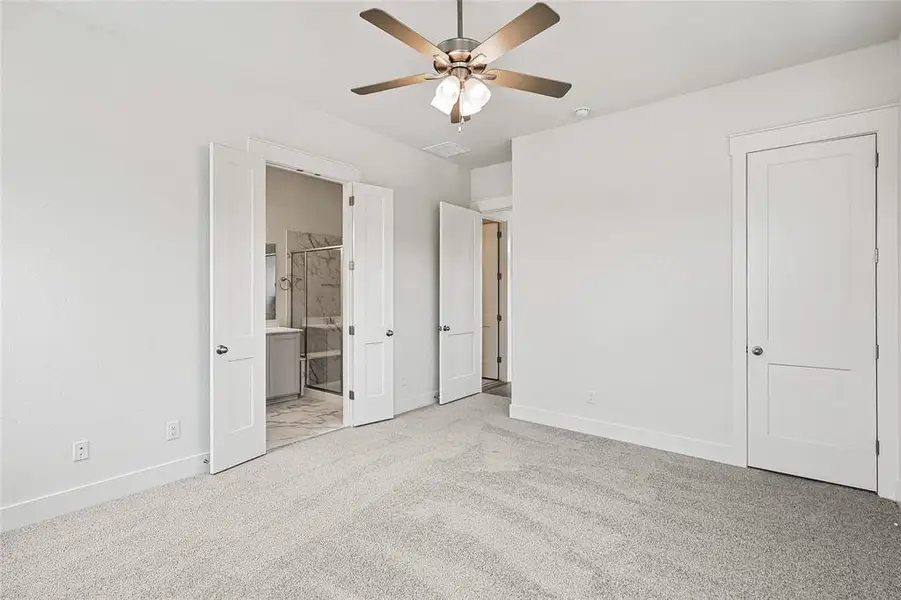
[0,452,210,531]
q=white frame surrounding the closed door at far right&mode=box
[729,104,901,500]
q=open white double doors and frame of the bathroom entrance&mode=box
[209,138,394,473]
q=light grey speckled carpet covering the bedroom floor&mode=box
[2,395,901,600]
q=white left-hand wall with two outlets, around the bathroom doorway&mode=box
[2,3,468,527]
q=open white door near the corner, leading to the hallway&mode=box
[438,202,482,404]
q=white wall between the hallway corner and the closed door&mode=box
[511,42,899,468]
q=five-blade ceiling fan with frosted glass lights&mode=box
[351,0,572,124]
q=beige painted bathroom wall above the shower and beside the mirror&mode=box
[266,167,344,327]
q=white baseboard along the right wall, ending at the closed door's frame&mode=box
[510,404,744,466]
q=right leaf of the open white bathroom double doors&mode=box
[348,183,394,425]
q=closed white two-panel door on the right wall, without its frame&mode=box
[748,135,876,490]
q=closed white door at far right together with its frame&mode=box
[730,106,901,499]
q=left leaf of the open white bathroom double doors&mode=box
[210,144,266,473]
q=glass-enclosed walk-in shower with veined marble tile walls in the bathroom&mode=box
[290,245,344,394]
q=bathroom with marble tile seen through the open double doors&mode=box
[265,166,344,450]
